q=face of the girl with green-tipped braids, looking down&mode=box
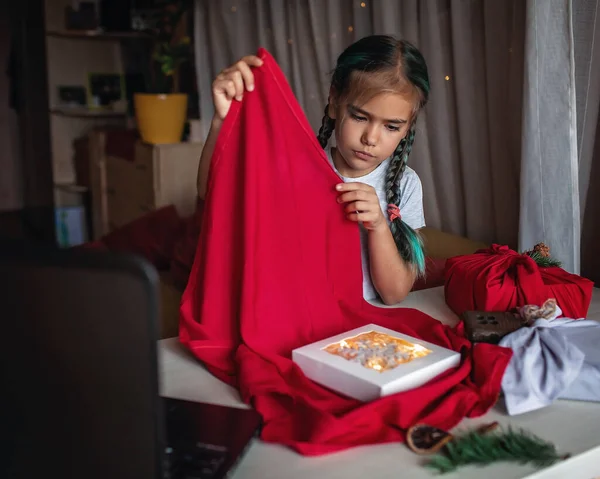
[329,93,414,178]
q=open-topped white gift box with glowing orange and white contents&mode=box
[292,324,460,401]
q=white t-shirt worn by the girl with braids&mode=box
[327,148,425,300]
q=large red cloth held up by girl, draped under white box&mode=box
[180,50,511,455]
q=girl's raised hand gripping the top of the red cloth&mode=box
[212,55,263,121]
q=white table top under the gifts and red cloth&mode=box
[159,288,600,479]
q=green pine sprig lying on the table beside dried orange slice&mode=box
[425,427,564,474]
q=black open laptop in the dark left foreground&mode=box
[0,242,260,479]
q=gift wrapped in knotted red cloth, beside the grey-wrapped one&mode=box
[445,245,594,318]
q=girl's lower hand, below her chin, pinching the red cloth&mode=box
[335,183,387,231]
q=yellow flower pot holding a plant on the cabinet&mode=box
[133,93,187,144]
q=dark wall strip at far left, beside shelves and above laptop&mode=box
[0,0,55,242]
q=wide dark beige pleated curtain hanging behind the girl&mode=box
[195,0,525,247]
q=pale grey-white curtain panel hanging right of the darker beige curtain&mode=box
[519,0,581,273]
